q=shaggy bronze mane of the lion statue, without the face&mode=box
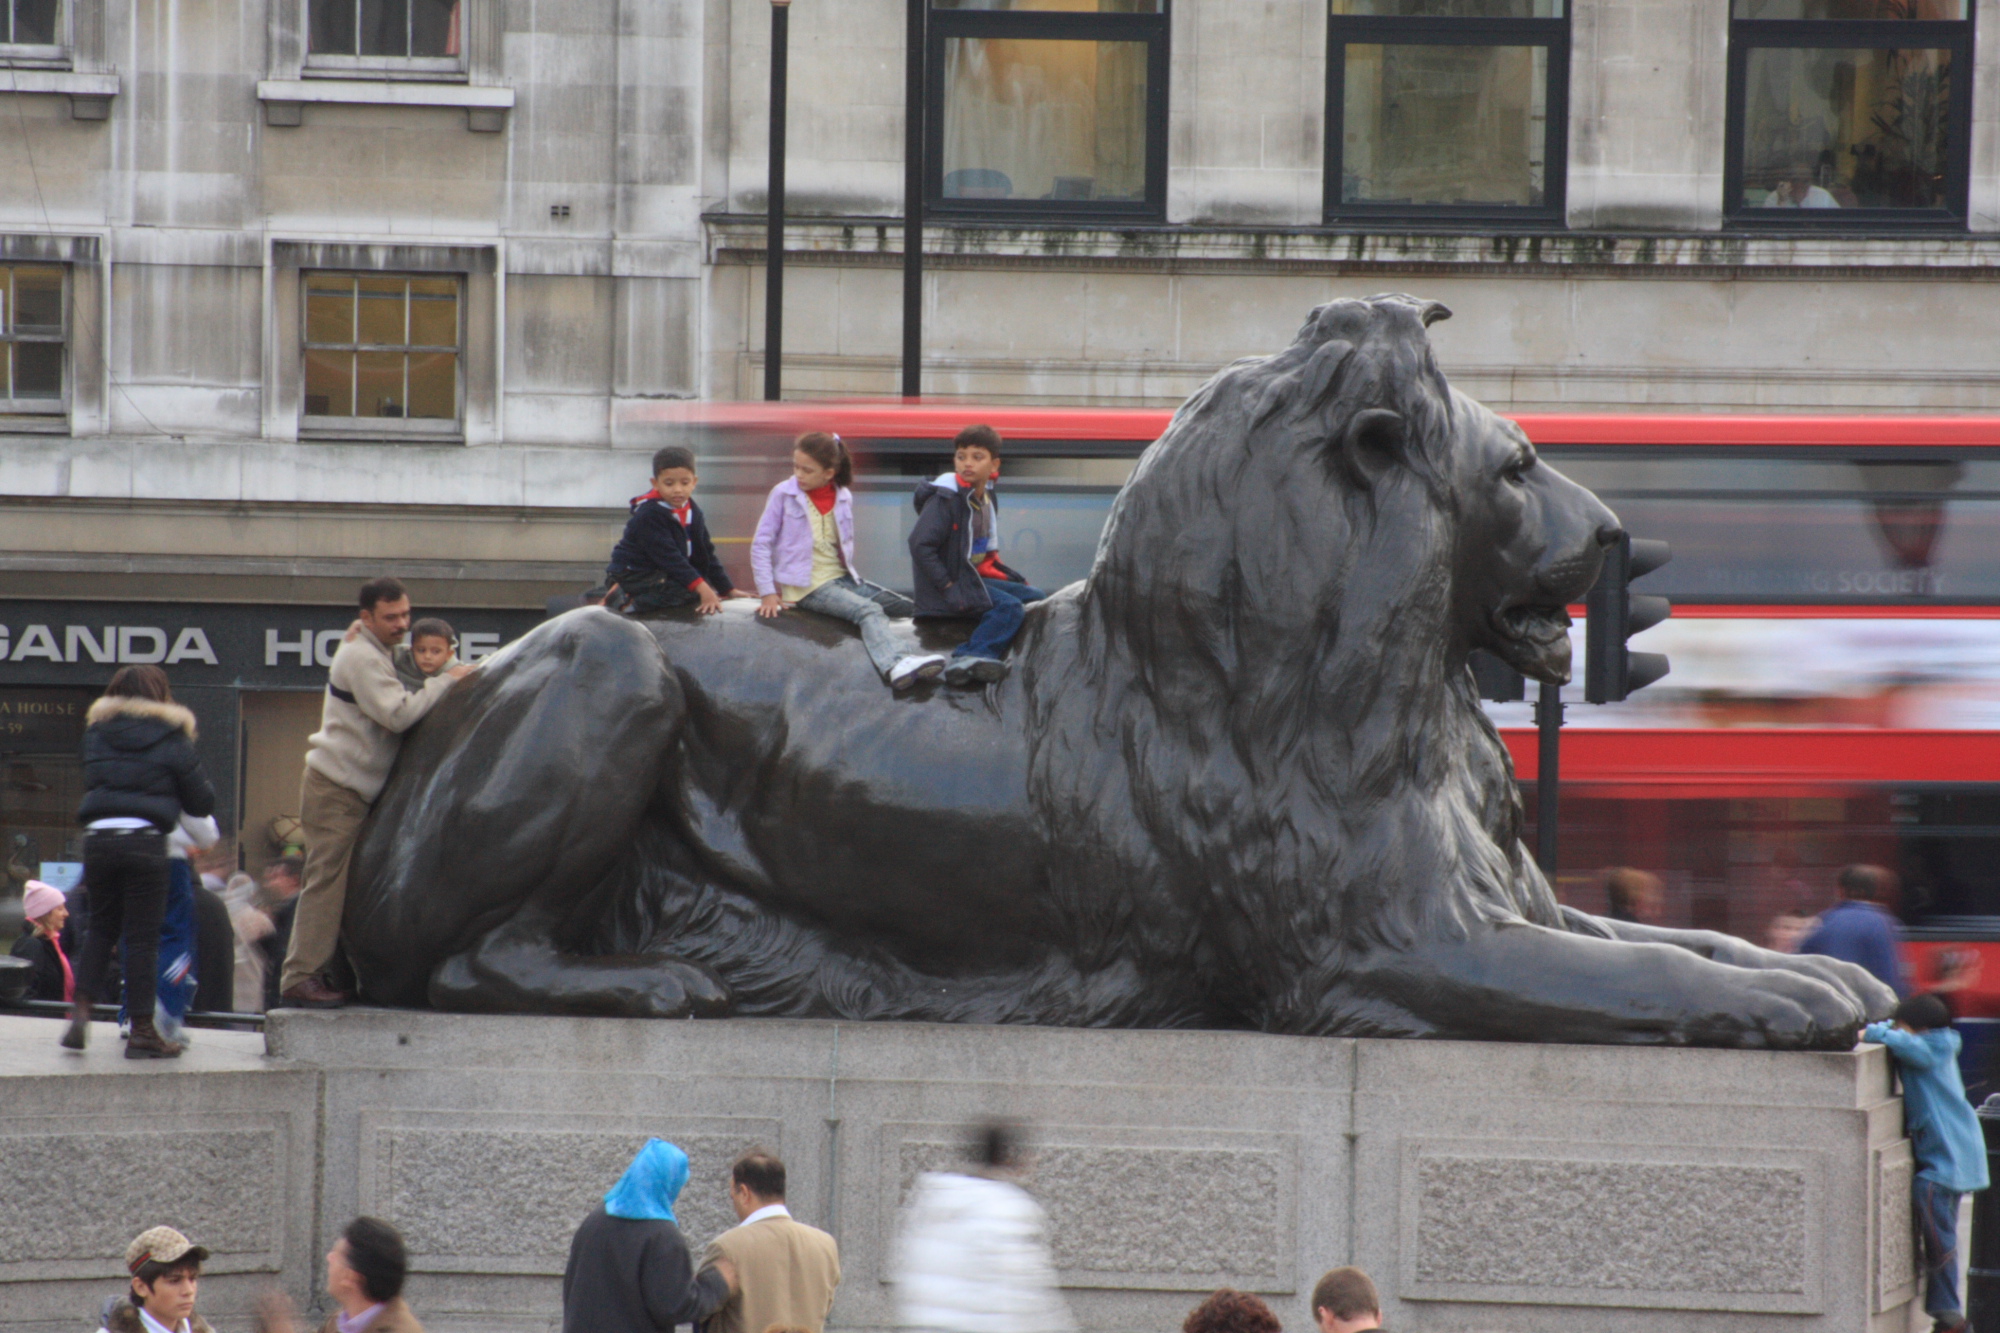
[1024,296,1560,1033]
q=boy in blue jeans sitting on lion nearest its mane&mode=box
[910,426,1046,685]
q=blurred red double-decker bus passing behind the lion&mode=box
[634,400,2000,1072]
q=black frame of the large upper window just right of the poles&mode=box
[924,0,1172,222]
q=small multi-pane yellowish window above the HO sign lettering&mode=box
[302,272,464,432]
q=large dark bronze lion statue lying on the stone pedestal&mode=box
[344,296,1894,1049]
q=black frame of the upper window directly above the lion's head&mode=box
[1322,0,1576,228]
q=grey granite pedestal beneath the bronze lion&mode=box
[0,1011,1916,1333]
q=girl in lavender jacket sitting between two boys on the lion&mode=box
[750,430,946,691]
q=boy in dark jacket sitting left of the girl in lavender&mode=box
[604,444,750,616]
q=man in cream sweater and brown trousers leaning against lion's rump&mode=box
[278,578,472,1009]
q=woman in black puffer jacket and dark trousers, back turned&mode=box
[62,667,216,1059]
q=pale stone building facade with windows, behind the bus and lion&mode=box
[0,0,2000,844]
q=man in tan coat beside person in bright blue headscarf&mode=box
[702,1149,840,1333]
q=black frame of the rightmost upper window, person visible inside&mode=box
[1722,11,1976,232]
